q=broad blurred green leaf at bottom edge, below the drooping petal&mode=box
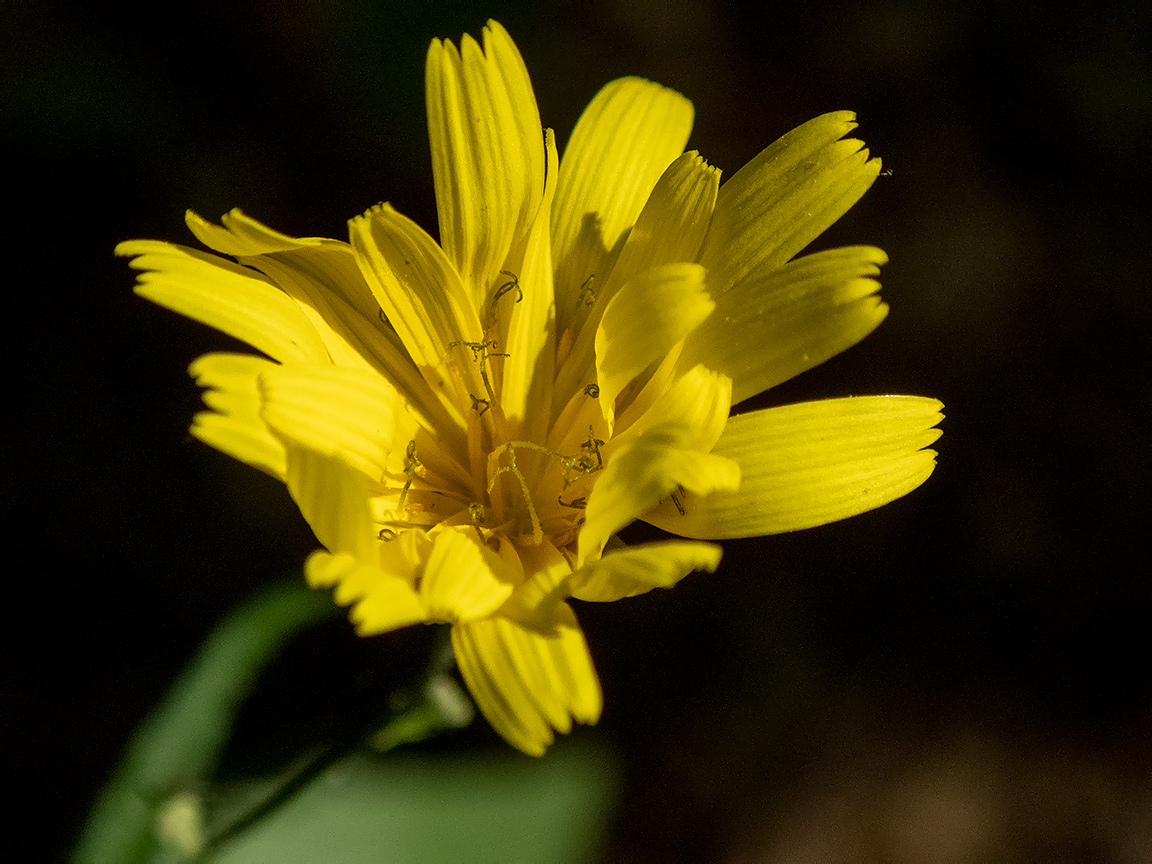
[211,736,619,864]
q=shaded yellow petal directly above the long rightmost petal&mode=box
[679,247,888,402]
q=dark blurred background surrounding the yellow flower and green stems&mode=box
[0,0,1152,862]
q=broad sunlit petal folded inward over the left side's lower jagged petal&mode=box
[259,363,403,480]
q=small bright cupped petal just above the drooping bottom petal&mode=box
[420,529,511,622]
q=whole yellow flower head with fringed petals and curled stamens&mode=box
[118,22,941,753]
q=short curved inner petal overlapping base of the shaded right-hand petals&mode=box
[596,264,715,424]
